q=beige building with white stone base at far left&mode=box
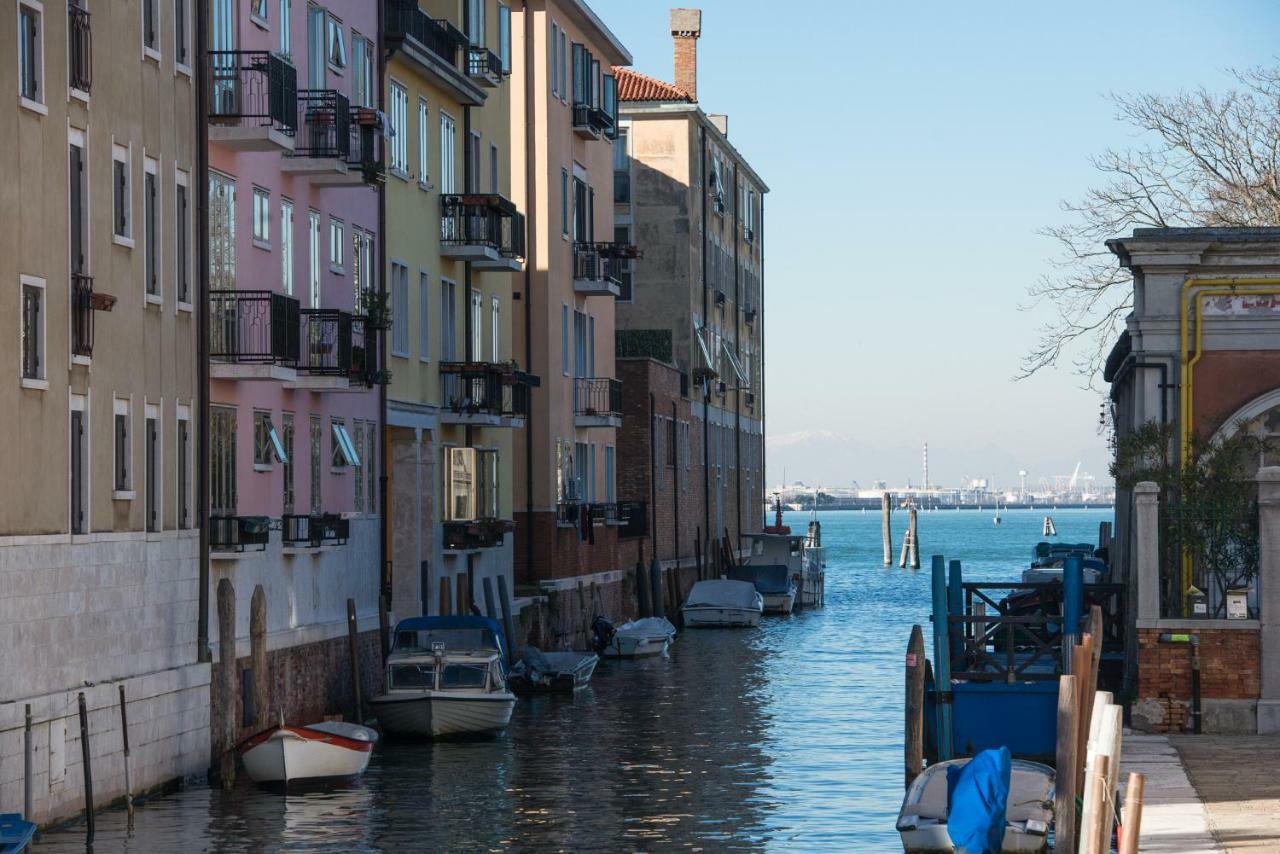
[0,0,210,822]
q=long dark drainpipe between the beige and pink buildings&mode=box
[192,3,214,662]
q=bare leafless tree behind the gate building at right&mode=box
[1019,68,1280,384]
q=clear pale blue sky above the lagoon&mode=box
[589,0,1280,487]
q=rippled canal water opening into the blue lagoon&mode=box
[36,511,1110,854]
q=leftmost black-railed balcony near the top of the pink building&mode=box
[207,50,298,151]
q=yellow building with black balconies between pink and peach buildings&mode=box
[384,0,529,617]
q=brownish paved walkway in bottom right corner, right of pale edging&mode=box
[1167,735,1280,854]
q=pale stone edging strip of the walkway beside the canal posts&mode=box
[1120,732,1218,854]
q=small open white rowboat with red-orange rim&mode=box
[239,721,378,784]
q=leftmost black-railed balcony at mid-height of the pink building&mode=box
[209,291,301,383]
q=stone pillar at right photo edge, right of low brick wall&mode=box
[1257,466,1280,735]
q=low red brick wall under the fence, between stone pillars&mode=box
[1135,629,1262,732]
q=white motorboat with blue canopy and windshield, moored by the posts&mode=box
[370,616,516,737]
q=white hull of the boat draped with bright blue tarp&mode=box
[897,750,1053,854]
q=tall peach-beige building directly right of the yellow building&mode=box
[512,0,631,601]
